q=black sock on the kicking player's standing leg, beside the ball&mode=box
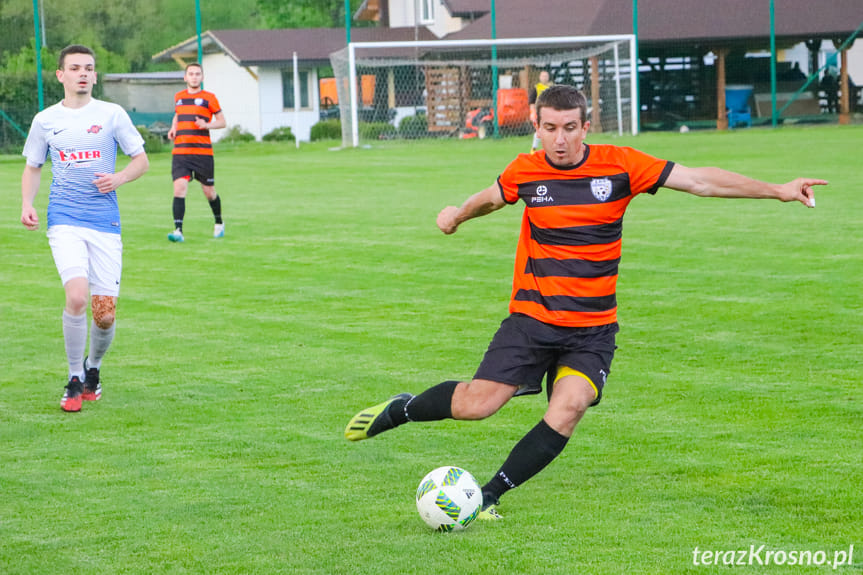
[482,419,569,505]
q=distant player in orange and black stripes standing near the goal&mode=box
[168,62,227,242]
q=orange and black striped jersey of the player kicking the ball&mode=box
[498,145,674,327]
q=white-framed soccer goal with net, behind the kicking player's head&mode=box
[330,35,638,147]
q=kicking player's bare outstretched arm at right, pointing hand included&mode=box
[664,164,827,208]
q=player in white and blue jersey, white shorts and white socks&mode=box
[21,45,149,411]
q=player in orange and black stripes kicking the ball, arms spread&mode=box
[345,86,827,519]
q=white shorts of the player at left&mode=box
[48,225,123,297]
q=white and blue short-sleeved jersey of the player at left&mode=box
[23,100,144,234]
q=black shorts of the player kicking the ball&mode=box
[474,313,620,405]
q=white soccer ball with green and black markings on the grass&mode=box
[417,466,482,532]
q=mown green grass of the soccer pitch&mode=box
[0,126,863,575]
